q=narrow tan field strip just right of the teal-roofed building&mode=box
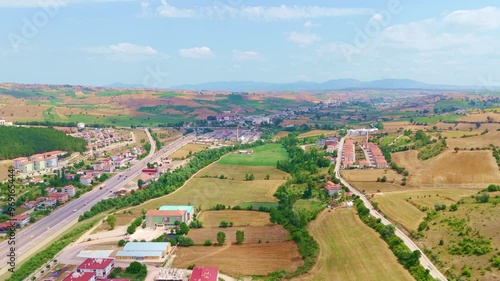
[198,210,271,228]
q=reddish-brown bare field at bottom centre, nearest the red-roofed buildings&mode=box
[174,241,302,276]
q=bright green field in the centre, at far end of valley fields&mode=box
[218,144,288,166]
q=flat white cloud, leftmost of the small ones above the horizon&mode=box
[84,43,168,61]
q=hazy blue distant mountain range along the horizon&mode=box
[108,79,486,92]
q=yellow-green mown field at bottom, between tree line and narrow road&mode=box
[294,209,414,281]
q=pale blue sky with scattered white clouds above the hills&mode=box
[0,0,500,88]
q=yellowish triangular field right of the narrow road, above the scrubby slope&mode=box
[371,188,478,232]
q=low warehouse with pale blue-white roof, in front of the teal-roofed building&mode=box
[116,242,170,261]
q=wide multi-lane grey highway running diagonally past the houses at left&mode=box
[0,129,195,276]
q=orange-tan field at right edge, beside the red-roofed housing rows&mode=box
[392,149,500,188]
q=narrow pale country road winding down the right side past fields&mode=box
[335,138,448,281]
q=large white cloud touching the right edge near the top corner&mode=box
[444,7,500,29]
